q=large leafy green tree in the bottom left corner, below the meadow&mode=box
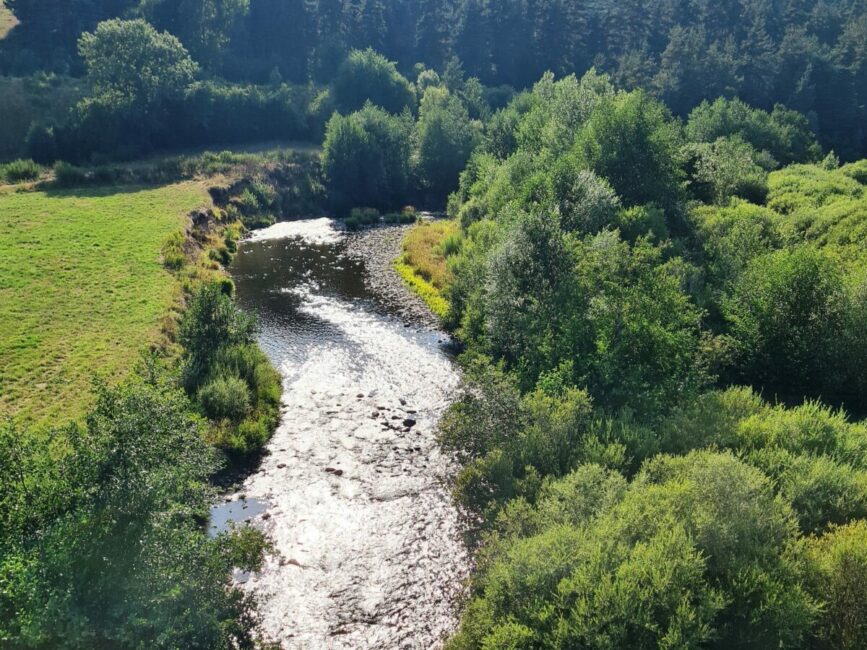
[0,376,263,650]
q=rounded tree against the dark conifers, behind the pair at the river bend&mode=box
[334,49,415,113]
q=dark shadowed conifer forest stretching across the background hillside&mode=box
[0,0,867,159]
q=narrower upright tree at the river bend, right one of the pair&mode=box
[415,88,481,198]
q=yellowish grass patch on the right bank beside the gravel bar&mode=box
[394,220,459,318]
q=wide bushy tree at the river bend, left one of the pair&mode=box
[322,104,412,213]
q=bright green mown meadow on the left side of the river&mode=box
[0,182,208,425]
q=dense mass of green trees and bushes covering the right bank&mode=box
[400,72,867,649]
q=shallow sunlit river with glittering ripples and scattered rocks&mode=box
[224,219,467,649]
